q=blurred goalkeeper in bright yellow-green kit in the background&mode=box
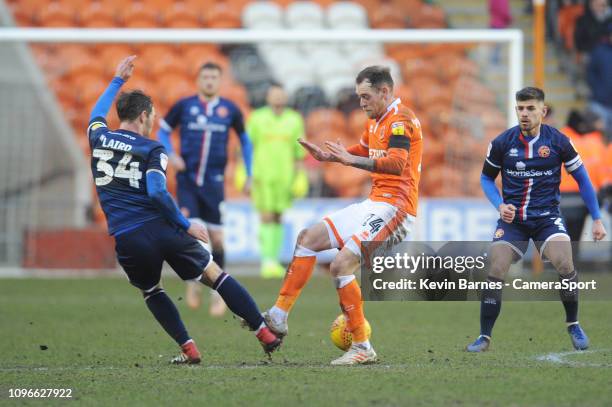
[247,83,308,278]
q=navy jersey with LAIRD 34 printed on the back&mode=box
[87,117,168,236]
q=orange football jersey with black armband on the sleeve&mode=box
[361,98,423,216]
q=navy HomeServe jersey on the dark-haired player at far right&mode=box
[483,125,582,222]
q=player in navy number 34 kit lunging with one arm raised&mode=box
[87,56,280,364]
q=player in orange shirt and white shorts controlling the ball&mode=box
[264,66,423,365]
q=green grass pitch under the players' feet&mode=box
[0,277,612,406]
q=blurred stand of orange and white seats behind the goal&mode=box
[8,0,506,226]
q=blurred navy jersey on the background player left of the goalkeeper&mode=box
[160,95,244,186]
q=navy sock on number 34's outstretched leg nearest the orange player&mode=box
[213,273,263,331]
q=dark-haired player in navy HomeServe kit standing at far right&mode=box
[467,87,606,352]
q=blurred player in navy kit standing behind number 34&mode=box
[158,62,253,316]
